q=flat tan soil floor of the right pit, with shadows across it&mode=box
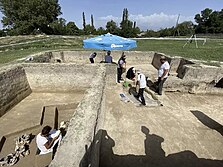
[100,64,223,167]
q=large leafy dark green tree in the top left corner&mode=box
[0,0,61,34]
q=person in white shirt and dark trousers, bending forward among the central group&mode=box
[136,70,146,106]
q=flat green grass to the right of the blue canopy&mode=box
[135,40,223,61]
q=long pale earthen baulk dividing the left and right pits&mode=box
[50,66,106,167]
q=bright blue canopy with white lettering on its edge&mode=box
[83,33,137,50]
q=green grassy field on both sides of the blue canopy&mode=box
[0,35,223,64]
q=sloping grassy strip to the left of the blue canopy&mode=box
[0,36,82,64]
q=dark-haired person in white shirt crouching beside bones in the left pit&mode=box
[36,125,62,154]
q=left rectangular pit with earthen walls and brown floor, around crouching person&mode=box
[0,64,97,167]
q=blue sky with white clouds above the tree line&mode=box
[0,0,223,30]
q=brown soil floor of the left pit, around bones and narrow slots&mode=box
[0,90,85,167]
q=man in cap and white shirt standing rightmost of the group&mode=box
[156,56,170,95]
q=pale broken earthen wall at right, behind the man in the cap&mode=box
[152,53,223,94]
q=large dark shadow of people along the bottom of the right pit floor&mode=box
[100,126,223,167]
